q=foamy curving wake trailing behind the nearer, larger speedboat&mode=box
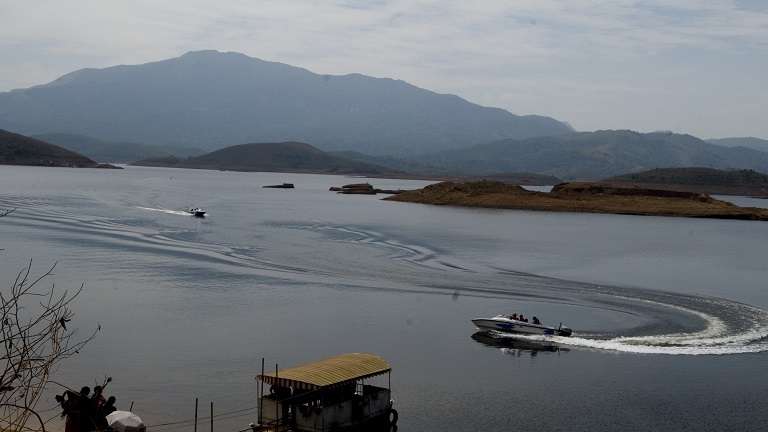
[256,224,768,355]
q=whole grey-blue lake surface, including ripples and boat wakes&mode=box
[0,166,768,431]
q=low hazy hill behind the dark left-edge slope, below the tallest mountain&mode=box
[33,133,205,163]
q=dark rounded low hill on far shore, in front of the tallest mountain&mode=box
[133,142,399,175]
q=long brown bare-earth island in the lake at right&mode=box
[384,181,768,220]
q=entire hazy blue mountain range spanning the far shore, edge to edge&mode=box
[0,51,768,179]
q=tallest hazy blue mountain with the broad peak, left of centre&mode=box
[0,51,572,155]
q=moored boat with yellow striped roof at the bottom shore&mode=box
[257,353,397,432]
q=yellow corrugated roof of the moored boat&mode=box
[258,353,391,387]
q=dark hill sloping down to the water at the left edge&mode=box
[0,129,114,168]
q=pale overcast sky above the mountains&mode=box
[0,0,768,138]
